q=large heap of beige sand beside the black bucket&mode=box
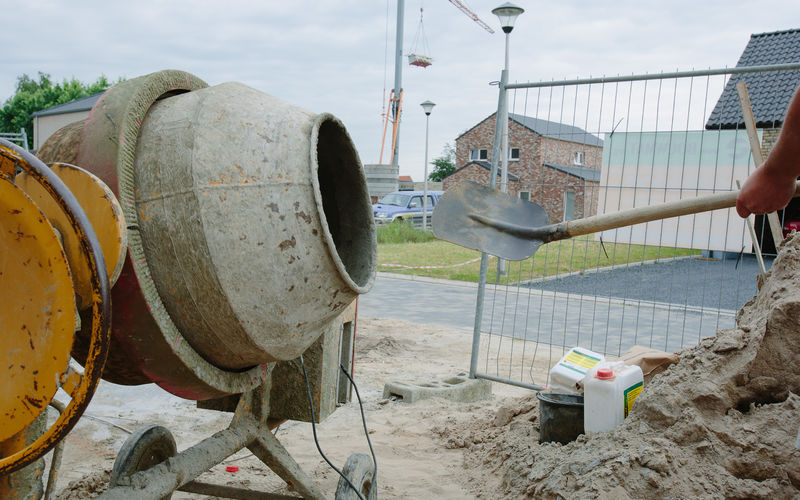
[433,235,800,499]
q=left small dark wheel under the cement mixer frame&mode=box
[111,425,178,498]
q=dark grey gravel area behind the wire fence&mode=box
[528,254,772,310]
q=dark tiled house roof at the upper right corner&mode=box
[706,28,800,129]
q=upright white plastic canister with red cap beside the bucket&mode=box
[583,363,644,434]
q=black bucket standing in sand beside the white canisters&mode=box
[536,392,583,444]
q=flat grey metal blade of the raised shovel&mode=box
[431,181,547,260]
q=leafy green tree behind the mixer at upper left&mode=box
[0,71,111,148]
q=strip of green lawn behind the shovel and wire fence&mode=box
[378,236,700,283]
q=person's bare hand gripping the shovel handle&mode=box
[736,163,795,218]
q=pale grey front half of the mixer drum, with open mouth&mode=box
[134,83,374,369]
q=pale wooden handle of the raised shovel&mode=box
[566,183,800,238]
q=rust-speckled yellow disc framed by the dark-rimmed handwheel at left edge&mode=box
[0,177,75,441]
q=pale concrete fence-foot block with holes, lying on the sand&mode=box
[383,372,492,403]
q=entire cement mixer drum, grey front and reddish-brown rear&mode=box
[34,70,377,399]
